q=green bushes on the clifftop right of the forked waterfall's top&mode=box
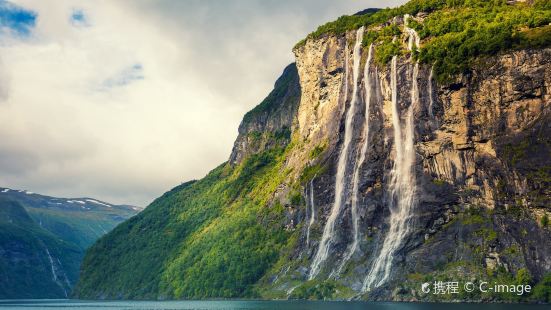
[418,1,551,81]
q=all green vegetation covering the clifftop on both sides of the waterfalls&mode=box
[295,0,551,82]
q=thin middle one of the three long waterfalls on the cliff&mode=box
[336,44,373,275]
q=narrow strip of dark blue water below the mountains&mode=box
[0,300,551,310]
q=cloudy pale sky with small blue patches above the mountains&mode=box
[0,0,405,206]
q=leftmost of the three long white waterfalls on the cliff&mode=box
[308,27,364,280]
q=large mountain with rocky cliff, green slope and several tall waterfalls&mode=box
[74,0,551,302]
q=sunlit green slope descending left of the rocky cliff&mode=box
[77,146,300,298]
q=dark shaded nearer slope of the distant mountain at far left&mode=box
[0,198,83,299]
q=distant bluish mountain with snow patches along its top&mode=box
[0,188,140,299]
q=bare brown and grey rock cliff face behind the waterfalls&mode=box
[256,25,551,300]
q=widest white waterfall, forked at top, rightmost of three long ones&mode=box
[363,15,419,291]
